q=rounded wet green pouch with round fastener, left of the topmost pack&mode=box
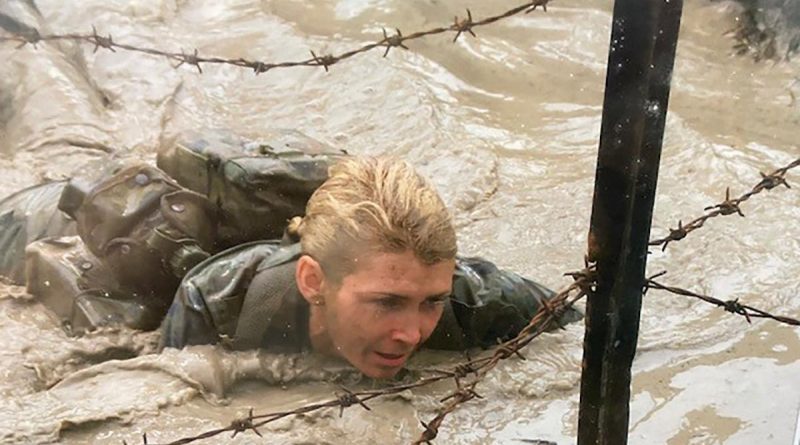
[60,164,219,300]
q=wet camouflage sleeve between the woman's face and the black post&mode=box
[426,258,582,350]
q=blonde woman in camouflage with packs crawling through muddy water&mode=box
[0,129,580,378]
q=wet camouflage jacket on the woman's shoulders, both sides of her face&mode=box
[161,242,581,352]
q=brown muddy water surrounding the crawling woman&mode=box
[0,0,800,445]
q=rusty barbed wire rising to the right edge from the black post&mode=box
[649,158,800,251]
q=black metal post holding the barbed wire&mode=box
[578,0,683,445]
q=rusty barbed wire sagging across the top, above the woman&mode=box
[0,0,550,75]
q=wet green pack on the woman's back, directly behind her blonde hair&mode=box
[156,129,343,247]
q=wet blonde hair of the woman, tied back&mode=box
[288,157,456,279]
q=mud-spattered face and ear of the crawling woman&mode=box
[312,251,455,378]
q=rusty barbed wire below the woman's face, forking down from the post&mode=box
[123,265,596,445]
